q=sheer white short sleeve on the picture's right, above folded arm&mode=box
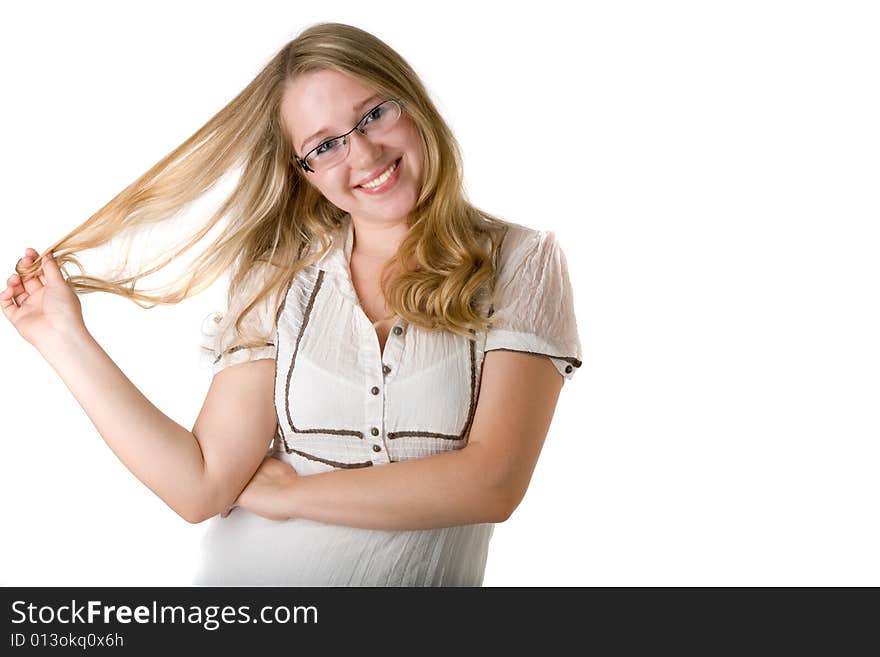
[485,229,583,379]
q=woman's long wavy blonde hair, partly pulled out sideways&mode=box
[16,23,508,358]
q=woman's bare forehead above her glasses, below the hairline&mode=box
[281,71,375,148]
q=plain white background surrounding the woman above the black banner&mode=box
[0,0,880,586]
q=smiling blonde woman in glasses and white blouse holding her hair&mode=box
[0,23,581,586]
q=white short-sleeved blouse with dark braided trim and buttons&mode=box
[194,215,582,586]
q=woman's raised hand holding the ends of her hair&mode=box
[0,249,86,351]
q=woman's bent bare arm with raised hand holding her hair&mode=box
[0,249,277,522]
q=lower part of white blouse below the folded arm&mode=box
[193,509,494,586]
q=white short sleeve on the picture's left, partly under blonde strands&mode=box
[202,265,278,375]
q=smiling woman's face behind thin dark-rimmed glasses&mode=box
[281,71,422,223]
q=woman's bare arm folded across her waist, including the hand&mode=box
[233,351,563,530]
